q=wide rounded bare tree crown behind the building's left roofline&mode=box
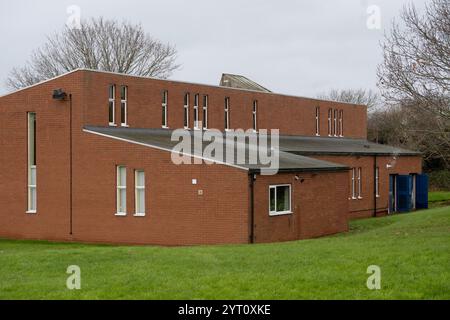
[6,18,179,89]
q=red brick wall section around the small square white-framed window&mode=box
[254,172,348,242]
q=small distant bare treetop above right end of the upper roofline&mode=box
[317,89,380,110]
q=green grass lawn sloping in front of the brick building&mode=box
[0,207,450,299]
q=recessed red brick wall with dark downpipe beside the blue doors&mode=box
[314,156,422,218]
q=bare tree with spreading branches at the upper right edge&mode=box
[378,0,450,119]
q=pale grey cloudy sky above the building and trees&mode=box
[0,0,425,96]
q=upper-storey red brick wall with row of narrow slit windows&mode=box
[83,71,367,138]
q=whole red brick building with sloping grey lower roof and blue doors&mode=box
[0,70,424,245]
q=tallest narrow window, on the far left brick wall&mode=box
[27,112,37,213]
